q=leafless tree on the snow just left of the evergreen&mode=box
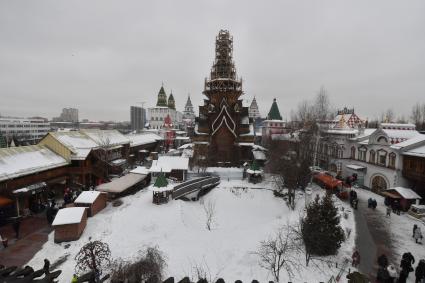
[256,223,301,282]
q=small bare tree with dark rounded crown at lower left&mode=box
[75,241,111,275]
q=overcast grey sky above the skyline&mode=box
[0,0,425,120]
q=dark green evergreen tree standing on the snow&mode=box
[301,195,345,263]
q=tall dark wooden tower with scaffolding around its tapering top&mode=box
[194,30,254,166]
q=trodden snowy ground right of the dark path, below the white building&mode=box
[357,189,425,282]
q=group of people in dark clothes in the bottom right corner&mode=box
[376,252,425,283]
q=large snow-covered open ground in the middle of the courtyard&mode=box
[29,180,355,282]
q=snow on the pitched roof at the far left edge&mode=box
[0,145,68,181]
